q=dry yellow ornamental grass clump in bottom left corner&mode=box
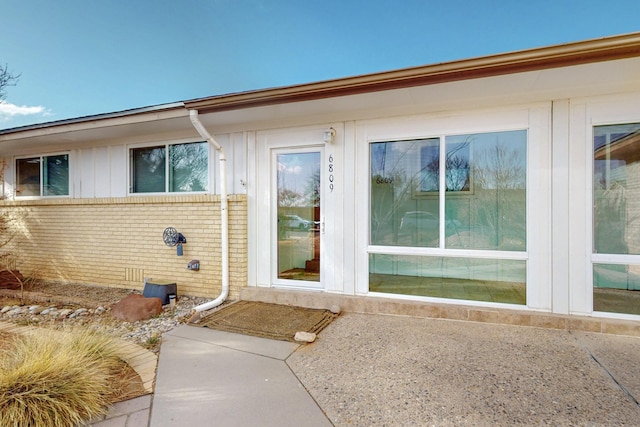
[0,330,122,427]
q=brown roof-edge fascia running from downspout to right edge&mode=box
[184,33,640,113]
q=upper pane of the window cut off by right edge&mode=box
[593,123,640,255]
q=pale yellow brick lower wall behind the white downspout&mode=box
[0,195,247,299]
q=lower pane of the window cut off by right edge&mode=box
[593,264,640,314]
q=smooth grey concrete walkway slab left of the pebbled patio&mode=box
[149,326,332,427]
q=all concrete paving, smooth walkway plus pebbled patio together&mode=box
[87,313,640,427]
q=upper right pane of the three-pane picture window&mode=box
[445,130,527,251]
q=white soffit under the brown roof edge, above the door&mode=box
[195,58,640,132]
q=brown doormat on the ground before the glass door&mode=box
[198,301,338,342]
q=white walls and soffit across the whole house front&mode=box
[4,53,640,318]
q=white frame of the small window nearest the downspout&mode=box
[126,139,214,197]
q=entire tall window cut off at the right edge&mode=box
[593,123,640,314]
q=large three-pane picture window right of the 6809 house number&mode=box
[369,130,527,304]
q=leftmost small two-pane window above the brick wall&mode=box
[16,154,69,197]
